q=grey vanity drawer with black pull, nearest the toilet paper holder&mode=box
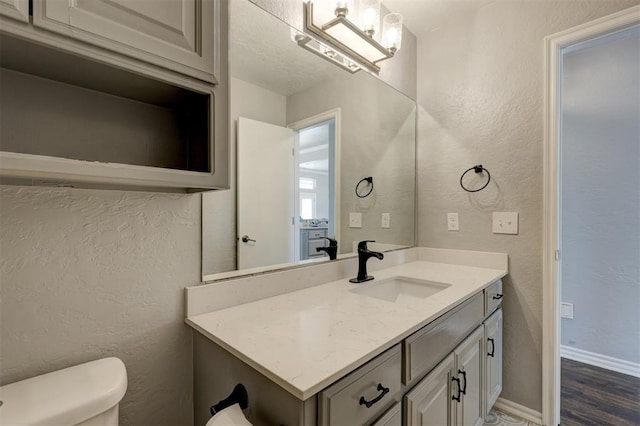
[318,345,402,426]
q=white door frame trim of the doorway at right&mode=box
[542,5,640,426]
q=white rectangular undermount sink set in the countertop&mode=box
[350,277,451,302]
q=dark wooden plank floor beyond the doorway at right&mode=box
[560,358,640,426]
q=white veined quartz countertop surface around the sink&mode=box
[187,260,507,400]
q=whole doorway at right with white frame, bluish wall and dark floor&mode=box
[543,7,640,425]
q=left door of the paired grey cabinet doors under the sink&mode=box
[404,353,457,426]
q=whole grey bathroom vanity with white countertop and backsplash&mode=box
[187,248,507,425]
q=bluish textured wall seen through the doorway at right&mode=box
[561,28,640,364]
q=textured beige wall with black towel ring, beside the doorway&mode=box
[418,0,638,411]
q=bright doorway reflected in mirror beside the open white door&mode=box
[289,109,340,260]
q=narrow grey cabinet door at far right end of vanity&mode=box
[484,309,502,415]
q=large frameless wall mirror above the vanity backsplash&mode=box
[202,0,416,281]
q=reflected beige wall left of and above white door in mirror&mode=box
[202,78,286,275]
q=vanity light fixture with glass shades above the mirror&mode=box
[298,0,402,74]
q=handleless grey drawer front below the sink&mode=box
[402,293,484,385]
